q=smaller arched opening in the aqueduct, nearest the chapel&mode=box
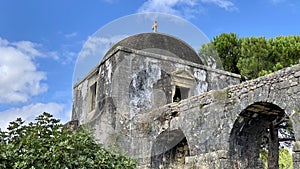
[151,130,190,169]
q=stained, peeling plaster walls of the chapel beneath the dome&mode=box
[72,47,240,156]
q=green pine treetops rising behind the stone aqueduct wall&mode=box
[199,33,300,79]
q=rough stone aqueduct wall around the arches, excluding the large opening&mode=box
[136,65,300,168]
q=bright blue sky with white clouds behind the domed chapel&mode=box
[0,0,300,129]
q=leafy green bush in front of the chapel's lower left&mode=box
[0,113,137,169]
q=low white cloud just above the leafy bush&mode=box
[0,103,65,130]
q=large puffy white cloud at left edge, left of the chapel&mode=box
[0,38,47,104]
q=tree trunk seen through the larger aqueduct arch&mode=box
[268,123,279,169]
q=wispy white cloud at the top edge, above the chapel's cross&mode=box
[138,0,237,18]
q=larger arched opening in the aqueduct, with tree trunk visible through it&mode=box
[230,102,295,169]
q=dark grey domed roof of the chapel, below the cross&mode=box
[107,33,202,64]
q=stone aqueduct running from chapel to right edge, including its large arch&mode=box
[139,65,300,169]
